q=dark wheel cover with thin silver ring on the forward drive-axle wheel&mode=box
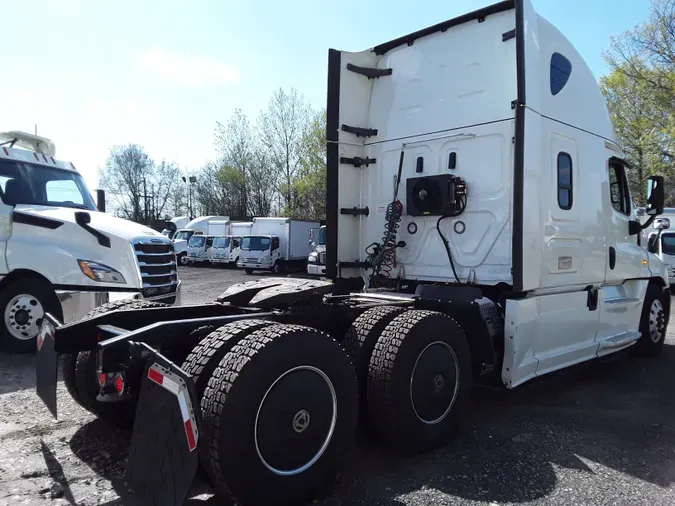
[410,341,459,425]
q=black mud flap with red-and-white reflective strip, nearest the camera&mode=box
[126,354,201,506]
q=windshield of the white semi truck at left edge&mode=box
[0,160,96,211]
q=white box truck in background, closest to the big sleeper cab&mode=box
[237,218,320,274]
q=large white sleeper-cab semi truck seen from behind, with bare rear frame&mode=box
[30,0,670,506]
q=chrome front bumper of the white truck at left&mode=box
[56,280,182,323]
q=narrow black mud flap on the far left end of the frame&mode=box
[35,313,60,418]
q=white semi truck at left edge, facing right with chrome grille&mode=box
[0,132,180,352]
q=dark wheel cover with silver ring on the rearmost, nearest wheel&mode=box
[254,365,337,476]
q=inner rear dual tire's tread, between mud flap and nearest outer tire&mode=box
[181,320,275,401]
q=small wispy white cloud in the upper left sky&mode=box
[136,47,239,86]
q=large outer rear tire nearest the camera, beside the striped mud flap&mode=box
[202,325,358,505]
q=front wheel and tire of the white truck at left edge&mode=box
[0,278,62,353]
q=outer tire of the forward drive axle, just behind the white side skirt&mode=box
[367,310,473,454]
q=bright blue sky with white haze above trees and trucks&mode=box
[0,0,649,188]
